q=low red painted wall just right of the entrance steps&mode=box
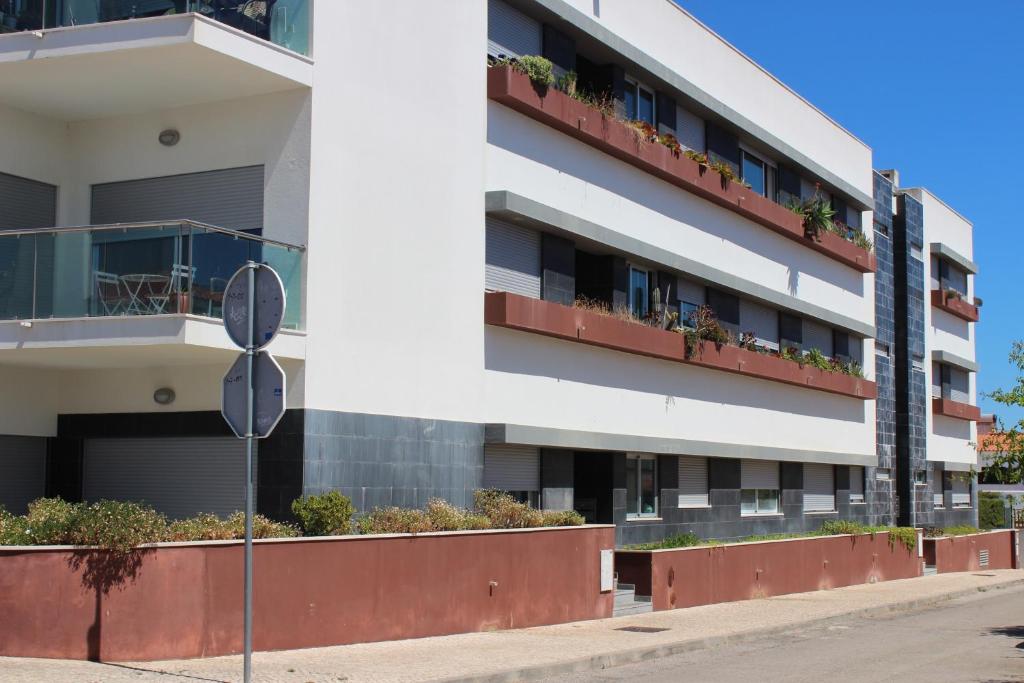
[615,533,922,609]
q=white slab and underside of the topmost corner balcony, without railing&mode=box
[0,14,312,121]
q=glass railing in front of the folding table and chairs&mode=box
[0,221,303,330]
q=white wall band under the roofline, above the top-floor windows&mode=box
[552,0,871,196]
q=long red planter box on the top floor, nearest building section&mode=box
[487,67,876,272]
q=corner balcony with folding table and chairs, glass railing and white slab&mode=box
[0,221,305,366]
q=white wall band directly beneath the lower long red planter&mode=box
[484,328,874,462]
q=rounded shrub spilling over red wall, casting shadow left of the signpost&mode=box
[70,501,167,553]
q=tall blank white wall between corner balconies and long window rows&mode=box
[306,1,487,420]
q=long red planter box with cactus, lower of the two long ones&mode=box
[483,292,878,400]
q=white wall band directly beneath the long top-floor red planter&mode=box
[486,102,874,325]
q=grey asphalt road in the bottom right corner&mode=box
[547,589,1024,683]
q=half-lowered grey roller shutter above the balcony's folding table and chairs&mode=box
[91,166,263,230]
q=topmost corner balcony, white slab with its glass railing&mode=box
[0,7,312,121]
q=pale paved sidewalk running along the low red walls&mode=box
[0,569,1024,683]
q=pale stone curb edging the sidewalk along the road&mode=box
[435,578,1024,683]
